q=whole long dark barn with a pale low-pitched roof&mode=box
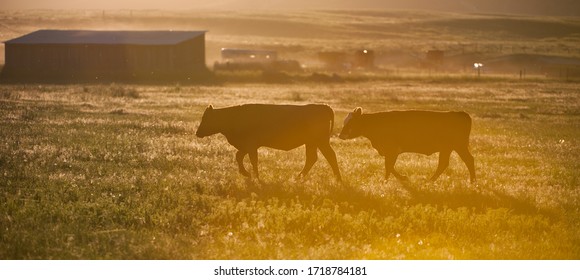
[2,30,207,81]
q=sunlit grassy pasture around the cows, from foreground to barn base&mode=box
[0,77,580,259]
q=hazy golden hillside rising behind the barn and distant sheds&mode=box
[0,10,580,75]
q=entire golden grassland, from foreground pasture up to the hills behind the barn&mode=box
[0,10,580,259]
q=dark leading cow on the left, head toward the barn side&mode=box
[195,104,341,181]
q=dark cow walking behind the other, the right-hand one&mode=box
[339,107,475,183]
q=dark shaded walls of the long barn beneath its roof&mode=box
[4,35,205,80]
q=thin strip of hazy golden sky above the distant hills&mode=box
[0,0,580,16]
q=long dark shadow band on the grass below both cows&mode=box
[214,174,557,218]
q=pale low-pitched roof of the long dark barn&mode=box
[4,30,206,45]
